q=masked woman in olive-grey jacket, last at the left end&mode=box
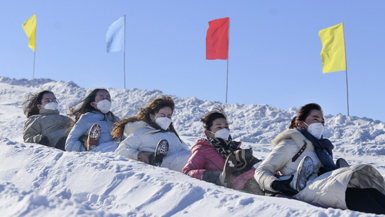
[23,90,73,150]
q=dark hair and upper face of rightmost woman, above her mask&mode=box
[289,103,325,130]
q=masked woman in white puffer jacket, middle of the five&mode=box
[112,96,189,172]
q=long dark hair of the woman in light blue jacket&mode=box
[70,88,115,125]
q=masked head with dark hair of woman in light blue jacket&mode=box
[71,88,111,122]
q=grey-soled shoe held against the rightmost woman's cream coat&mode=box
[296,156,314,191]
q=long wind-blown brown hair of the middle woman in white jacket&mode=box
[111,96,181,140]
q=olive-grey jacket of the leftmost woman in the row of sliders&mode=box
[23,109,73,147]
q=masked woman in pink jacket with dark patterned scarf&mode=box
[183,106,264,195]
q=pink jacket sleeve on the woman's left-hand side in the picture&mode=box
[182,145,206,179]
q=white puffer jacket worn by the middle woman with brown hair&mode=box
[115,121,190,172]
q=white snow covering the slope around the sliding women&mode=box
[0,77,385,217]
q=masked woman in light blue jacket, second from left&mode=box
[65,89,118,152]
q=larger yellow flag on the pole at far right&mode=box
[319,23,346,73]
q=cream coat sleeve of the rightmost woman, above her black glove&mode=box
[254,140,293,192]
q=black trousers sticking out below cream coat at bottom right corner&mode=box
[345,188,385,214]
